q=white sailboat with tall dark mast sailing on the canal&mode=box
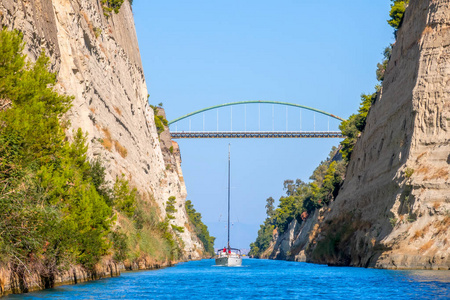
[216,144,242,267]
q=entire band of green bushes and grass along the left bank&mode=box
[0,29,192,286]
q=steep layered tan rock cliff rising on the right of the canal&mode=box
[262,0,450,269]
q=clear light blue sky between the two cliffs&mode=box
[133,0,394,248]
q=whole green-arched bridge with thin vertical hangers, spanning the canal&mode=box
[168,100,344,138]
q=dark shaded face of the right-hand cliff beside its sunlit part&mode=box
[306,1,429,267]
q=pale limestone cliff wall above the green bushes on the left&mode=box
[0,0,203,259]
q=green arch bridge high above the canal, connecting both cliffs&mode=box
[168,100,345,139]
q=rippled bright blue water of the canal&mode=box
[6,259,450,300]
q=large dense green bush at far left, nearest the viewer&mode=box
[0,29,112,274]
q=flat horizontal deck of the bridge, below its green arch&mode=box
[170,131,344,139]
